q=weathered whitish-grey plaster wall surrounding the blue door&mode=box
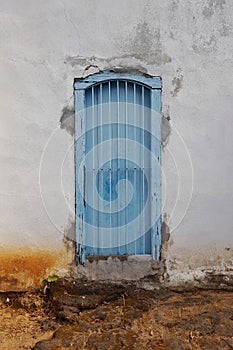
[0,0,233,283]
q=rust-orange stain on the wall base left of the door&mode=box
[0,249,69,291]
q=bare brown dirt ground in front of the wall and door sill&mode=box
[0,280,233,350]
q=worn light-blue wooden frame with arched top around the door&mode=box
[74,71,162,264]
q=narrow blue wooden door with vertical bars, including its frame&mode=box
[74,72,161,263]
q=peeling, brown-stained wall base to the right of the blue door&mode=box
[165,245,233,289]
